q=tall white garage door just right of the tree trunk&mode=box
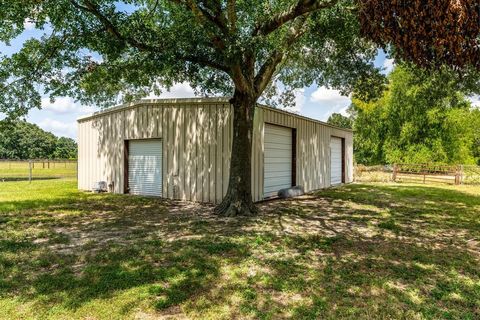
[263,124,292,198]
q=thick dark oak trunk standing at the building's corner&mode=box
[215,91,257,216]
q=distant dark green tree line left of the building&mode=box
[0,120,77,160]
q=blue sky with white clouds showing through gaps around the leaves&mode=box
[0,10,480,139]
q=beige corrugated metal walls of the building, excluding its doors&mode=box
[78,98,353,203]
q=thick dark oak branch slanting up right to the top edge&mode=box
[253,0,338,36]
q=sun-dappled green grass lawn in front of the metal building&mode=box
[0,180,480,319]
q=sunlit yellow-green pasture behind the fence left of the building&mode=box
[0,159,77,181]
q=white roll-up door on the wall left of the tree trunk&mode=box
[128,139,162,196]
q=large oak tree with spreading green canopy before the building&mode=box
[0,0,478,215]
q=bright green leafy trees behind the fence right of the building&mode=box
[328,65,480,165]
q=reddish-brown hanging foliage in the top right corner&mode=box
[359,0,480,69]
